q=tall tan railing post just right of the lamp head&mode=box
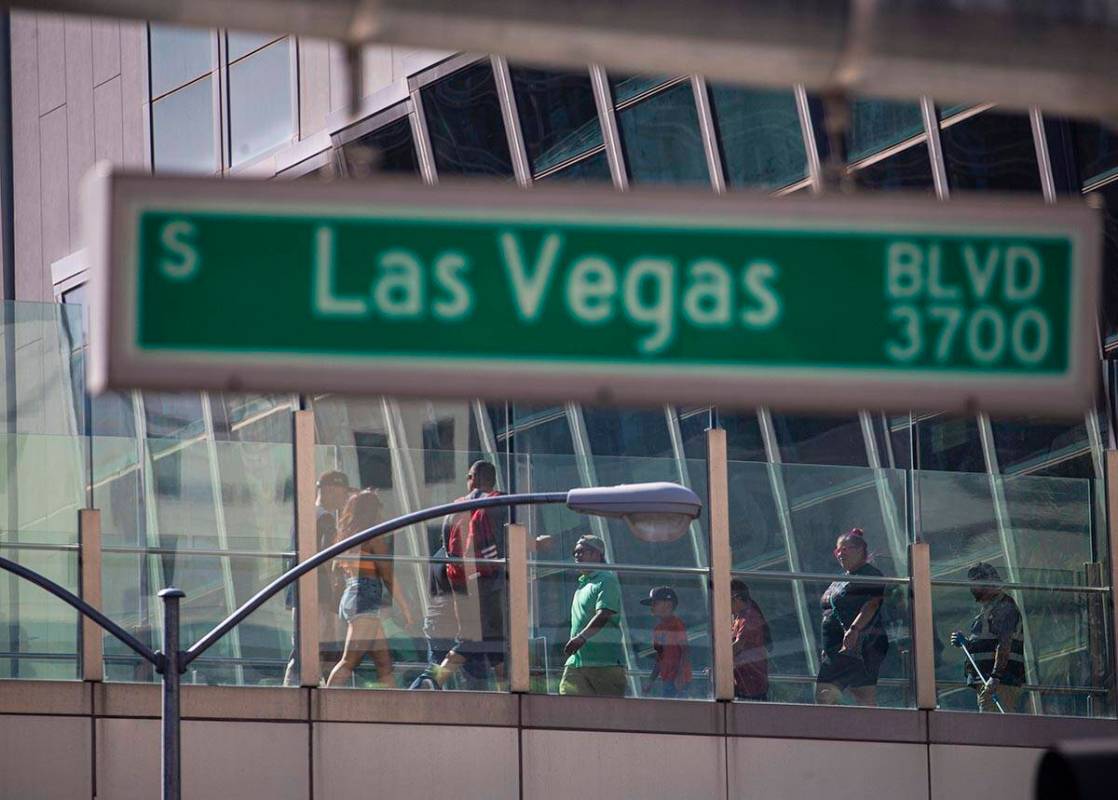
[707,428,733,701]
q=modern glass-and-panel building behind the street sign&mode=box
[0,11,1118,798]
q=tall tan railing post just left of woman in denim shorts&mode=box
[294,411,325,686]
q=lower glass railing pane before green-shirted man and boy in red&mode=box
[529,562,712,699]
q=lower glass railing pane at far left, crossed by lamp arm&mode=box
[0,549,80,680]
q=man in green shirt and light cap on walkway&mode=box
[559,536,626,697]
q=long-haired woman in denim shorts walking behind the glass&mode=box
[326,489,411,686]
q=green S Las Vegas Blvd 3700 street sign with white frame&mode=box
[87,170,1101,412]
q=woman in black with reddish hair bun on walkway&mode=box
[815,527,889,705]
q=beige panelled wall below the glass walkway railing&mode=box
[0,682,1104,800]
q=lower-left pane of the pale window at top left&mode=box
[151,77,217,173]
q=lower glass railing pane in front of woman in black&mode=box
[731,572,916,708]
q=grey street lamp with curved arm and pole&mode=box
[0,483,702,800]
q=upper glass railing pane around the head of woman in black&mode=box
[728,461,909,577]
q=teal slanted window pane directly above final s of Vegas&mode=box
[710,85,807,189]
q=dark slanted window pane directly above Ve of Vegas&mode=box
[509,67,601,173]
